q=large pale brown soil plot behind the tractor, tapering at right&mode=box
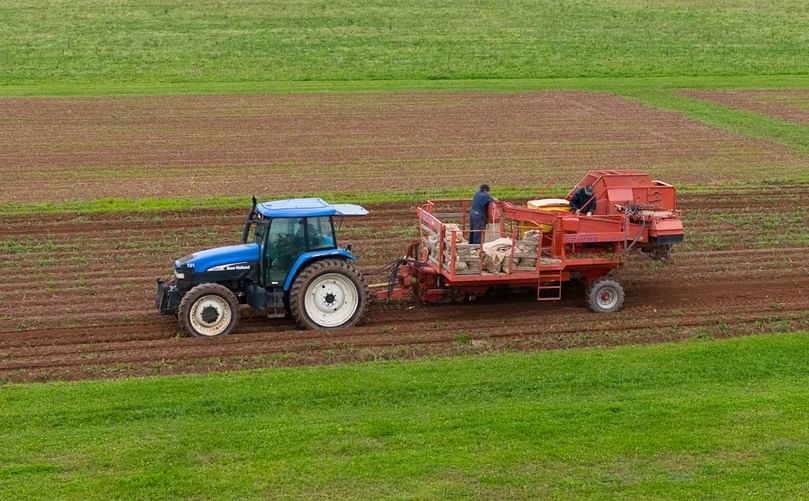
[0,92,805,203]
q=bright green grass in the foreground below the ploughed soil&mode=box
[0,333,809,499]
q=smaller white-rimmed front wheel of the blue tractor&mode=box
[177,283,239,337]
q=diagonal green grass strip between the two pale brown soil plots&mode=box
[621,90,809,156]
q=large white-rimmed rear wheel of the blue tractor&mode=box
[289,259,371,331]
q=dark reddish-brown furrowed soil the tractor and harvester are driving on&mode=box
[0,186,809,381]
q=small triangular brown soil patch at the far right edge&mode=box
[686,89,809,124]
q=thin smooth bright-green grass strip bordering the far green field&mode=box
[0,75,809,97]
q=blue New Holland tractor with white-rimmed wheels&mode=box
[156,197,370,337]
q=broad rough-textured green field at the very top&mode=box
[0,0,809,84]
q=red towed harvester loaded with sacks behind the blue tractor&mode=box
[377,170,683,313]
